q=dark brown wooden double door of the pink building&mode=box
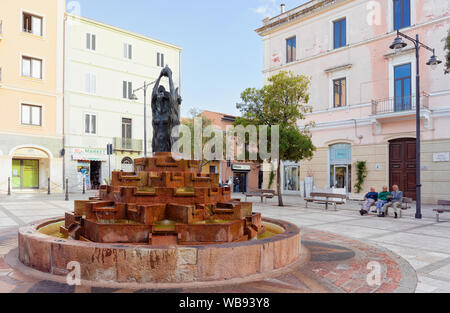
[389,138,416,200]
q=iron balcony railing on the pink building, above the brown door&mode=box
[372,93,429,115]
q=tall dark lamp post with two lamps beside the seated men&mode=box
[389,30,442,219]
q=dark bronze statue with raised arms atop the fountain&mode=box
[152,66,182,153]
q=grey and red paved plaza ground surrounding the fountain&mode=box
[0,193,450,293]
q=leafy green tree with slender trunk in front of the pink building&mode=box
[235,71,315,206]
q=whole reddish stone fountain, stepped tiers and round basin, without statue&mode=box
[19,153,300,284]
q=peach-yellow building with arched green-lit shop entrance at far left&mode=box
[0,0,65,192]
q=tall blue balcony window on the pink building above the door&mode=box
[394,63,411,112]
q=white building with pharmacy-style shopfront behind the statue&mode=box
[64,14,181,191]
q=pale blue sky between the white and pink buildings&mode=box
[67,0,306,116]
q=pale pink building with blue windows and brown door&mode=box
[257,0,450,203]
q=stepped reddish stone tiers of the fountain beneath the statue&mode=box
[61,153,264,246]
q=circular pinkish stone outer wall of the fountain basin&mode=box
[19,219,301,284]
